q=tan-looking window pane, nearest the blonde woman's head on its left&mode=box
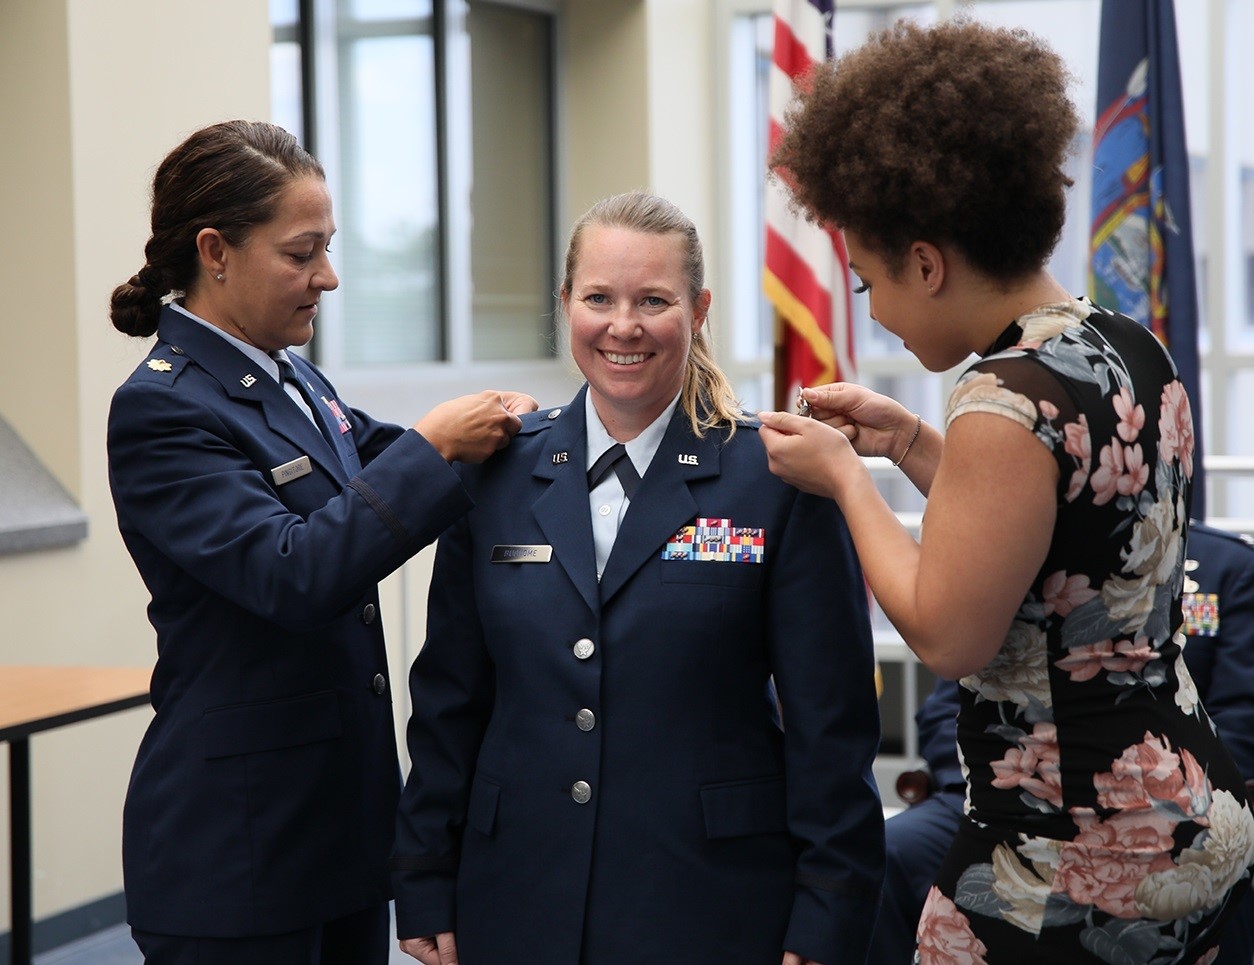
[466,3,556,361]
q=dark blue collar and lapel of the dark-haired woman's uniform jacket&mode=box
[157,307,349,485]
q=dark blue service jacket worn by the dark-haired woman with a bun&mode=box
[108,308,470,936]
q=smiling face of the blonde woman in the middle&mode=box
[562,224,710,441]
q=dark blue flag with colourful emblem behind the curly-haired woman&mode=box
[1090,0,1206,519]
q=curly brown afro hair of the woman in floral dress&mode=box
[771,19,1078,281]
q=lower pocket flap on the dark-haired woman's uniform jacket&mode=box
[202,691,344,758]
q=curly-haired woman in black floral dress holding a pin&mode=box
[761,20,1254,965]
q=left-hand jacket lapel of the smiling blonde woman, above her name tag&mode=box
[532,386,598,612]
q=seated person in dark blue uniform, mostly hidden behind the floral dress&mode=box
[870,523,1254,965]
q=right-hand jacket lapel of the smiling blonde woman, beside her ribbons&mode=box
[599,406,722,605]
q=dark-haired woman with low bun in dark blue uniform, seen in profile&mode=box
[109,122,534,965]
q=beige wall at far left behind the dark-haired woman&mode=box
[0,0,270,929]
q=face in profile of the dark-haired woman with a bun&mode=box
[187,177,340,352]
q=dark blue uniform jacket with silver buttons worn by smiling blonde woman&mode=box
[393,387,883,965]
